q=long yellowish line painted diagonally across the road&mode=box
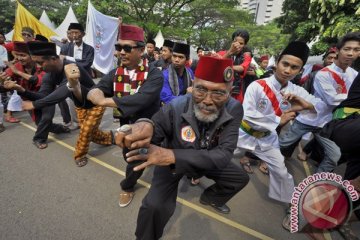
[20,122,274,240]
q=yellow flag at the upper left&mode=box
[12,2,57,41]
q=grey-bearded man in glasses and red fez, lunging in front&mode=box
[116,57,249,239]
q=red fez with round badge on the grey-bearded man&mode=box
[195,56,234,83]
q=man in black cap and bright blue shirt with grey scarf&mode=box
[160,43,194,104]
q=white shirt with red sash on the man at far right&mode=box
[296,63,358,127]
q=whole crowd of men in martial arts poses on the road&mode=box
[0,23,360,239]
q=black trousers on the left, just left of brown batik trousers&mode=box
[33,105,68,143]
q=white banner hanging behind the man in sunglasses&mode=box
[84,1,119,74]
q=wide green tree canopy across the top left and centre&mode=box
[0,0,289,54]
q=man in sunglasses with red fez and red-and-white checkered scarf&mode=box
[68,25,163,207]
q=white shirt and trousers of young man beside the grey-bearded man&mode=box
[237,76,324,203]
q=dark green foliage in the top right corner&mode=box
[276,0,360,55]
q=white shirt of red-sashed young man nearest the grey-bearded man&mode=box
[237,76,324,150]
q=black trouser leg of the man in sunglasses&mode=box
[120,148,144,192]
